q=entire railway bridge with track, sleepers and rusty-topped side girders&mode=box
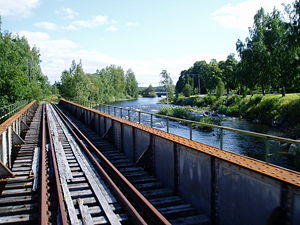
[0,100,300,225]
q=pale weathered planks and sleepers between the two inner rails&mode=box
[47,103,129,224]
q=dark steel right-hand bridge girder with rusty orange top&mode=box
[59,100,300,225]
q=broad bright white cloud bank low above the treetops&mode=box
[19,31,227,86]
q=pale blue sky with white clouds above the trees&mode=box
[0,0,293,86]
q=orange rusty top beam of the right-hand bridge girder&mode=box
[61,99,300,187]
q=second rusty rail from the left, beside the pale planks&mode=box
[45,106,68,225]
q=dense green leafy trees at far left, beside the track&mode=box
[0,22,50,105]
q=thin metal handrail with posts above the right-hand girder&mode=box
[80,102,300,169]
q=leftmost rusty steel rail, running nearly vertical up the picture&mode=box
[40,105,49,224]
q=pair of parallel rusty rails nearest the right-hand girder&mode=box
[54,106,170,224]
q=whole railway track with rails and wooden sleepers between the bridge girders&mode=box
[0,105,209,225]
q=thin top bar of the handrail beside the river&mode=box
[99,104,300,145]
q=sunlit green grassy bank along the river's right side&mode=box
[169,94,300,138]
